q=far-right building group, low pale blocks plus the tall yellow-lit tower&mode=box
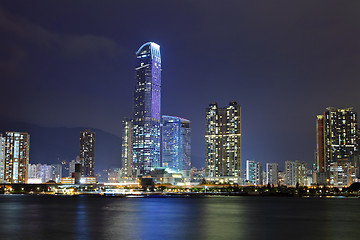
[240,107,360,187]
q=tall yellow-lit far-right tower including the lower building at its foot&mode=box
[316,107,358,186]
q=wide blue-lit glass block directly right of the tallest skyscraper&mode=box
[162,116,191,172]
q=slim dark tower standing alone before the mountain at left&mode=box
[80,129,95,177]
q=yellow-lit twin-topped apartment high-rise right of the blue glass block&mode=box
[205,102,241,177]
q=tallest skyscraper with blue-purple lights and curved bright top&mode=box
[132,42,161,175]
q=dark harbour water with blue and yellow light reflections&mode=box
[0,195,360,240]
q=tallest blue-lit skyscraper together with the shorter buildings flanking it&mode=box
[119,42,191,183]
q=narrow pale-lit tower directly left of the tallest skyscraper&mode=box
[121,118,133,178]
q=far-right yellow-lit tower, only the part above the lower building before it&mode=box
[316,107,358,172]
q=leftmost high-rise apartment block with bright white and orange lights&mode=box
[4,132,30,183]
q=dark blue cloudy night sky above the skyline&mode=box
[0,0,360,171]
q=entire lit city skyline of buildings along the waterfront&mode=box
[0,42,360,187]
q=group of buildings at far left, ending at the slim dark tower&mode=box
[0,130,96,184]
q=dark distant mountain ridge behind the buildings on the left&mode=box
[0,120,121,173]
